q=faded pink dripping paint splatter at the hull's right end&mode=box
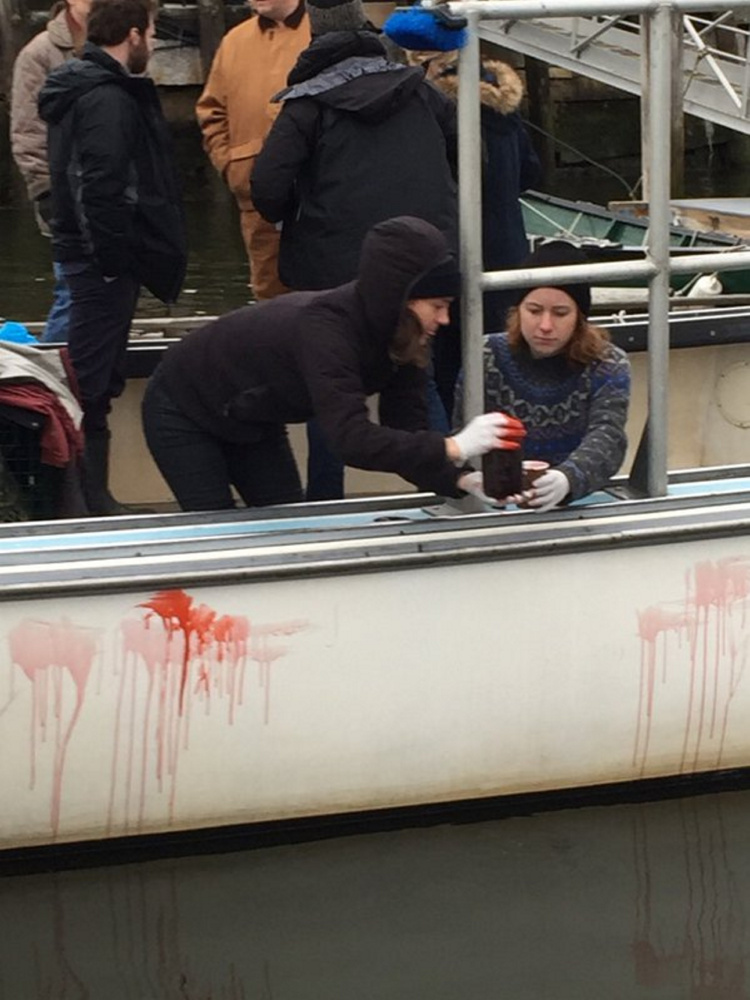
[633,558,750,774]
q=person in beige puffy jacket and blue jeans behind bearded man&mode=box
[10,0,91,343]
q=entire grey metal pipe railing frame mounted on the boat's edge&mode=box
[449,0,750,496]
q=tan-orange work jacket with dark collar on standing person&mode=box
[196,14,310,208]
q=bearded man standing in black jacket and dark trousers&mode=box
[39,0,186,515]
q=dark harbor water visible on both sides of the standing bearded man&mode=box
[0,198,250,322]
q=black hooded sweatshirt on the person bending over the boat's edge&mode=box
[159,217,462,496]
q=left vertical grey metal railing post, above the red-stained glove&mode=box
[458,13,484,421]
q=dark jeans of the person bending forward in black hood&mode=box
[142,369,302,510]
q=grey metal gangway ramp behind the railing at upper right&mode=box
[478,11,750,135]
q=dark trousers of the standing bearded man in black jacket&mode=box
[61,261,140,433]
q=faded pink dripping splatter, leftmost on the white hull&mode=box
[8,618,98,835]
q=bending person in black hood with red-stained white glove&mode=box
[143,216,523,510]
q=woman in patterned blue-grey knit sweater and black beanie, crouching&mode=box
[454,240,630,511]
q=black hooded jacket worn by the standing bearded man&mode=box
[39,43,187,302]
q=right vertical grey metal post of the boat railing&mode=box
[647,2,672,496]
